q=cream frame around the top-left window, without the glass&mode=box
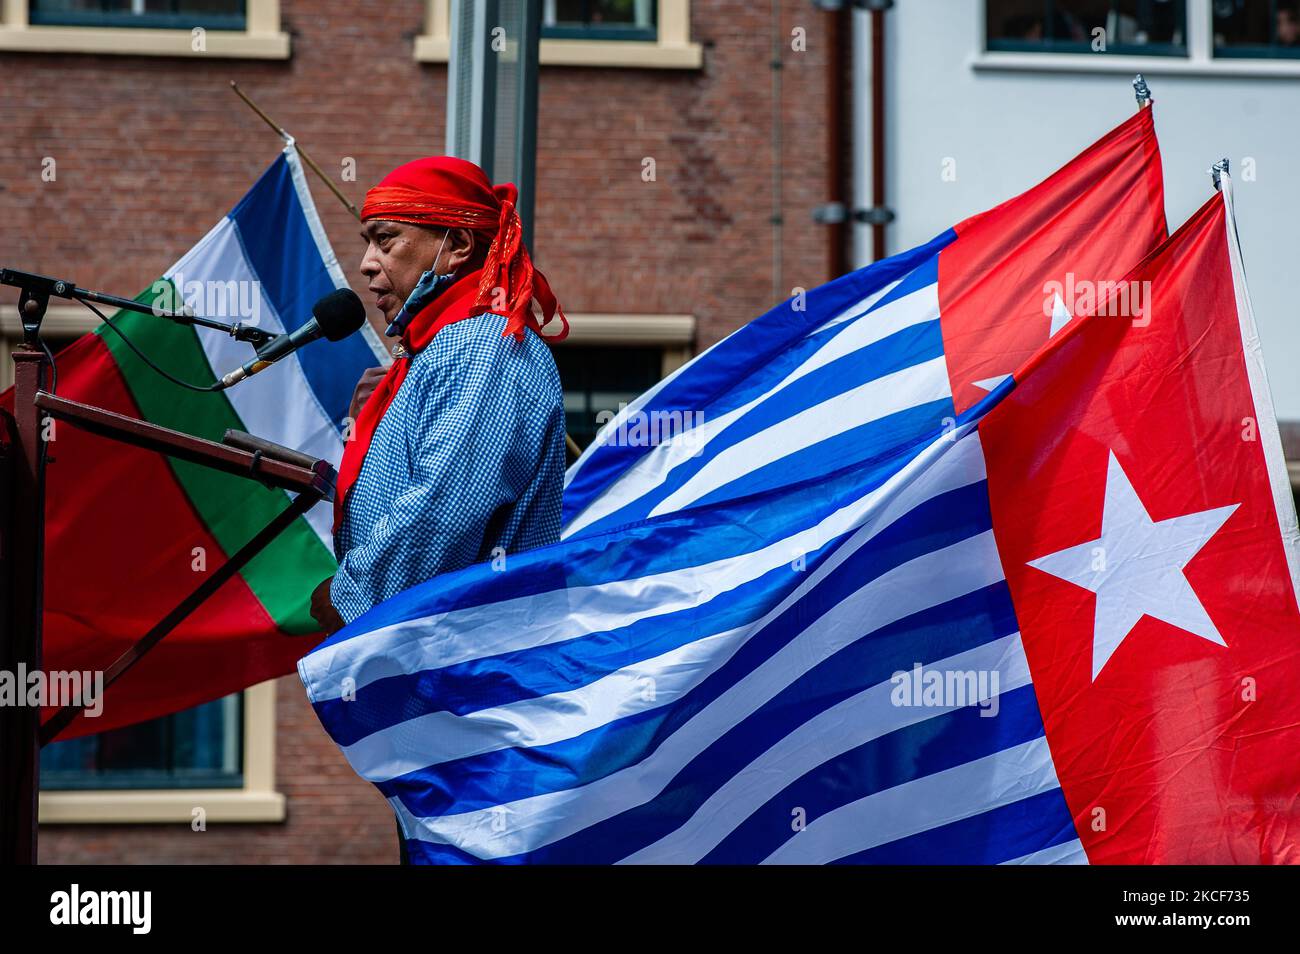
[0,0,290,60]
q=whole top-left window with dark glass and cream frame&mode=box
[0,0,289,60]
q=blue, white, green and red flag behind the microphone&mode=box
[3,146,384,738]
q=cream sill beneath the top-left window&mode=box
[0,26,289,60]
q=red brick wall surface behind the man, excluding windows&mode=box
[0,0,836,862]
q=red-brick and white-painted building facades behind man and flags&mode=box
[0,0,1300,863]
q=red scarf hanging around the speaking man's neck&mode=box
[334,265,488,533]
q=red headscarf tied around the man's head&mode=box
[361,156,568,341]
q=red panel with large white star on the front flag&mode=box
[980,177,1300,863]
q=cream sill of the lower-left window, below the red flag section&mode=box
[40,789,285,825]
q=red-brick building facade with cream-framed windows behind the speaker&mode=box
[0,0,841,863]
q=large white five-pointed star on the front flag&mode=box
[1030,452,1239,680]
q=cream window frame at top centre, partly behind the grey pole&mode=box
[415,0,705,70]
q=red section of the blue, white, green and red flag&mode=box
[0,334,309,740]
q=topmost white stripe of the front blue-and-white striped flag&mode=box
[298,415,984,702]
